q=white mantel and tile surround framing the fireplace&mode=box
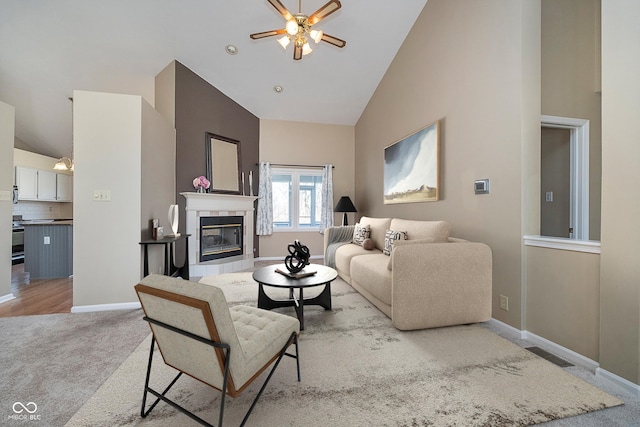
[180,193,257,278]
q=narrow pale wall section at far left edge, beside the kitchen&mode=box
[0,101,16,301]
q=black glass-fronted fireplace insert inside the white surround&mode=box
[199,216,244,262]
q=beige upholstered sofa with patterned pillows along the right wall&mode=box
[324,217,492,330]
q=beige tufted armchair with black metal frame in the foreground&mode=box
[135,274,300,426]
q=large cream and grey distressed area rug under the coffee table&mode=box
[67,273,622,427]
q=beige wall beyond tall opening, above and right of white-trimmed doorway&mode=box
[542,0,602,240]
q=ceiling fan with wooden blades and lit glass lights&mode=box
[249,0,347,60]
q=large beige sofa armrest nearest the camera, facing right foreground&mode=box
[391,243,492,330]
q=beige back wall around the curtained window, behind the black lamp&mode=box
[260,120,360,259]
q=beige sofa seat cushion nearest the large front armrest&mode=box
[351,253,391,305]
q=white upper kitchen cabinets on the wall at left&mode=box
[16,166,73,202]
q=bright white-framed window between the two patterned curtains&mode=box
[271,168,322,232]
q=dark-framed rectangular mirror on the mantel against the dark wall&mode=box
[205,132,242,194]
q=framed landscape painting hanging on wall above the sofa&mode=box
[384,121,440,204]
